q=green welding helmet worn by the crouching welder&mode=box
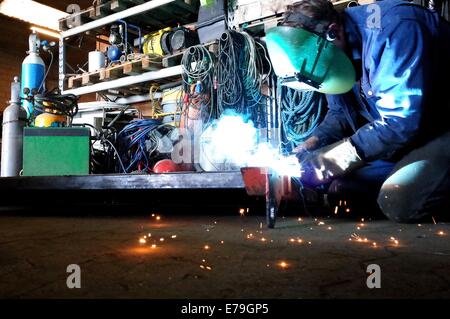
[266,26,355,94]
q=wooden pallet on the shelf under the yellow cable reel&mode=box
[67,56,162,89]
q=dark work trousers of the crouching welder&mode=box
[328,132,450,223]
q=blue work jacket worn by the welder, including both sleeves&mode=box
[313,0,450,161]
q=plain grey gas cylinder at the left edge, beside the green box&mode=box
[0,77,27,177]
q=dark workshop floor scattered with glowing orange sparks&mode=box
[0,214,450,298]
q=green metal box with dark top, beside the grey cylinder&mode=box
[23,127,90,176]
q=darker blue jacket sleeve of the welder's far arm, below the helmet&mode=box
[312,95,351,146]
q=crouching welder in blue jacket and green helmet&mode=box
[267,0,450,223]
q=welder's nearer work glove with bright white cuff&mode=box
[300,139,364,186]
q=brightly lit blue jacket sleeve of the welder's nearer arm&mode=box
[351,20,432,161]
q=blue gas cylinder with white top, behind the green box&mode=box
[20,32,45,118]
